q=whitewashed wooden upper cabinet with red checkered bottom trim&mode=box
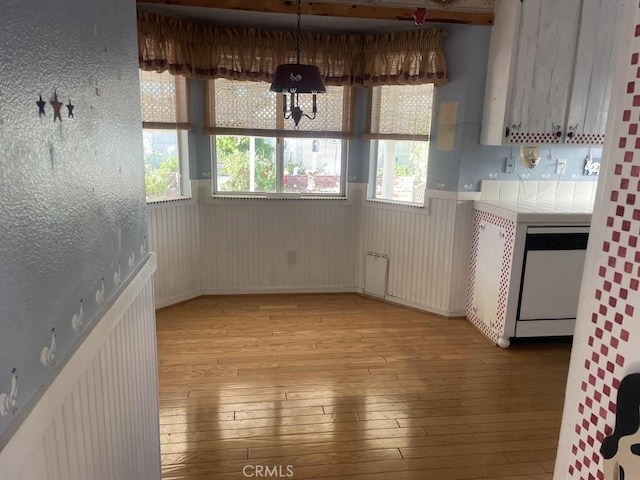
[481,0,620,145]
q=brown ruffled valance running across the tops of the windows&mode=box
[138,10,447,86]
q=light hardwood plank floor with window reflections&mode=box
[157,294,570,480]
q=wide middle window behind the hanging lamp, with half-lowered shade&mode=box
[205,79,350,196]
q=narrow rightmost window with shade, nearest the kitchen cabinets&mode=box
[365,84,433,205]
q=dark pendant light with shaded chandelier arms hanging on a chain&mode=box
[269,0,327,129]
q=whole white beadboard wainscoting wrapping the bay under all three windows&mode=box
[148,188,473,316]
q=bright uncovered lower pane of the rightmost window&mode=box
[375,140,429,205]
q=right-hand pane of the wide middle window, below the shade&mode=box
[283,138,343,194]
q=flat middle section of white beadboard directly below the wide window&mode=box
[200,200,356,294]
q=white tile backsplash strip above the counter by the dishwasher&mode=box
[480,180,598,205]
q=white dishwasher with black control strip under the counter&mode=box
[515,226,589,337]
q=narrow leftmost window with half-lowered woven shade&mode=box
[140,71,191,202]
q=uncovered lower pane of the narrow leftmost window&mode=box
[142,129,180,201]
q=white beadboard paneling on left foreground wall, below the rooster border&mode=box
[0,256,161,480]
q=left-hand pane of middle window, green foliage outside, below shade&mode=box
[215,135,276,192]
